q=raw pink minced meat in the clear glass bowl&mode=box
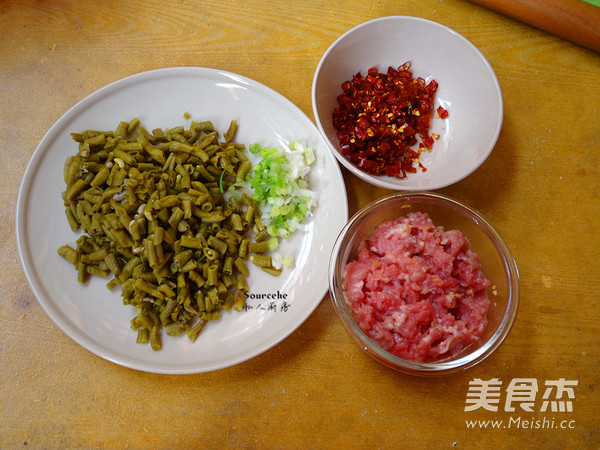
[344,212,490,362]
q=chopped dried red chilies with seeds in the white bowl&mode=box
[333,62,448,178]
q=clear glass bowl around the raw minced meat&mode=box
[329,192,519,376]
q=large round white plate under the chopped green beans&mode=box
[16,67,348,374]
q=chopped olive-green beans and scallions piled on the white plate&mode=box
[58,119,314,350]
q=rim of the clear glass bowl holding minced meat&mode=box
[328,191,519,376]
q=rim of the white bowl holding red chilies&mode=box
[311,15,504,192]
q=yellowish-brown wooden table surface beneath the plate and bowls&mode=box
[0,0,600,449]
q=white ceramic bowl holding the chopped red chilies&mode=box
[312,16,503,191]
